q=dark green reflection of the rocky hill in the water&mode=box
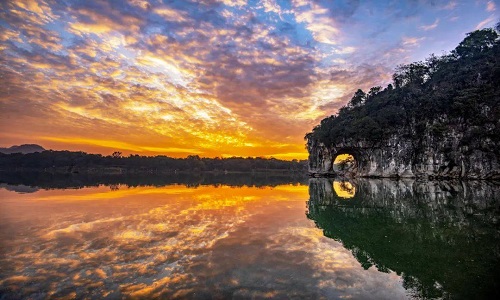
[307,179,500,299]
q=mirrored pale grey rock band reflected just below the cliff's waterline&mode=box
[308,178,500,226]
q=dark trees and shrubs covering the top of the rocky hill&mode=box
[305,23,500,145]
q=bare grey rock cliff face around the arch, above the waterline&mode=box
[307,125,500,179]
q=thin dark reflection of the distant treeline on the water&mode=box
[0,172,307,192]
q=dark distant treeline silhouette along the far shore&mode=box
[0,150,307,174]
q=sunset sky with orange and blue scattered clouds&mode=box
[0,0,500,159]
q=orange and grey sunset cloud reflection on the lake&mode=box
[0,185,405,298]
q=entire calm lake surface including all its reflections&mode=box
[0,176,500,299]
